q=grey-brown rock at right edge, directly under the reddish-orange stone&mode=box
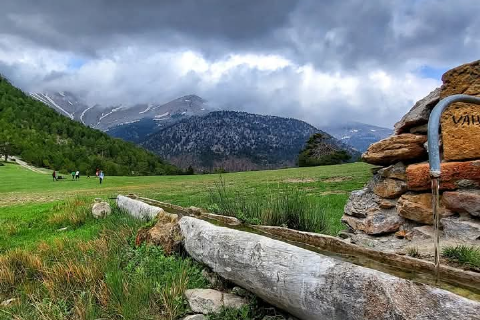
[442,190,480,217]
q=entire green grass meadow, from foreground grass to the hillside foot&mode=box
[0,163,371,320]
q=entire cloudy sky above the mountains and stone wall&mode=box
[0,0,480,127]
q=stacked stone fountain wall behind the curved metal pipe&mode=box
[342,60,480,244]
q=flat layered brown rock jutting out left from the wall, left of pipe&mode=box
[362,133,427,165]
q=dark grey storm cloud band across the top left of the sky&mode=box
[0,0,296,54]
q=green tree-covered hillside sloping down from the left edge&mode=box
[0,76,179,175]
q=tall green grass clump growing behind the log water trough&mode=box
[208,178,332,233]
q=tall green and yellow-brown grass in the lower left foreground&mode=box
[0,203,207,320]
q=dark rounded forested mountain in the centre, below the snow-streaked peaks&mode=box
[142,111,358,171]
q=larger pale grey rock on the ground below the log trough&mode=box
[185,289,247,314]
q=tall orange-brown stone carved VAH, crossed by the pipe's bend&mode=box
[440,60,480,161]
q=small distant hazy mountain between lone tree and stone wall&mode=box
[322,122,393,152]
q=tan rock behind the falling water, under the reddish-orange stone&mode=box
[397,193,454,225]
